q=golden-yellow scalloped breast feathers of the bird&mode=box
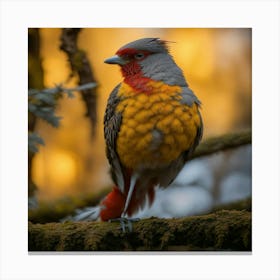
[117,82,201,169]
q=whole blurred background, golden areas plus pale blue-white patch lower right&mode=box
[29,28,252,221]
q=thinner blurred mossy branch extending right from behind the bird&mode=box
[190,130,252,159]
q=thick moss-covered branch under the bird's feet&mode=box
[28,210,251,251]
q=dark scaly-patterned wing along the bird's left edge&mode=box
[104,84,124,192]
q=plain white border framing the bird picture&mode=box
[0,0,280,280]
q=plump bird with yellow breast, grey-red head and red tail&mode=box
[64,38,203,229]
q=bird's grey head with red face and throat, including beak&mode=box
[104,38,186,88]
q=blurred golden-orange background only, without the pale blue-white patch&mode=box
[32,28,252,200]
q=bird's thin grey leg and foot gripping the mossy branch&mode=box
[109,174,139,232]
